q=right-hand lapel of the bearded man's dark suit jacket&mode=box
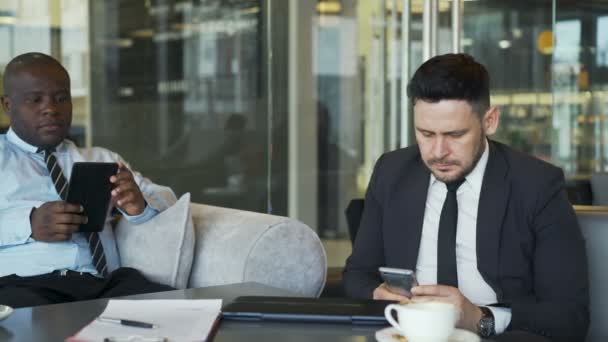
[476,141,511,290]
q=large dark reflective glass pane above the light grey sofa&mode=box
[91,0,284,213]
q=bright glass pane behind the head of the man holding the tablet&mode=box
[0,0,91,146]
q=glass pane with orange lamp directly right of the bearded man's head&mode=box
[462,1,554,160]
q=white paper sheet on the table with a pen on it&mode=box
[67,299,222,342]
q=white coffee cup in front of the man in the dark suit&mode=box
[384,302,458,342]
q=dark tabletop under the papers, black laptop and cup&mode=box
[0,283,552,342]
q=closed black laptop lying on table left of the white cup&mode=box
[222,296,394,325]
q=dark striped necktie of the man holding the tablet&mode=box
[43,149,108,277]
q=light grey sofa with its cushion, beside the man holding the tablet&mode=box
[115,195,327,297]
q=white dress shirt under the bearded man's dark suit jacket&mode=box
[416,141,511,333]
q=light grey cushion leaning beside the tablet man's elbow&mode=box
[115,193,194,289]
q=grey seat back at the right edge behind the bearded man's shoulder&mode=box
[574,206,608,341]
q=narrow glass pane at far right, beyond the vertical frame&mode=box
[552,1,608,176]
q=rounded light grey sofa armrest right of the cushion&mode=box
[189,204,327,296]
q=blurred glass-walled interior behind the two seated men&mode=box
[0,0,608,266]
